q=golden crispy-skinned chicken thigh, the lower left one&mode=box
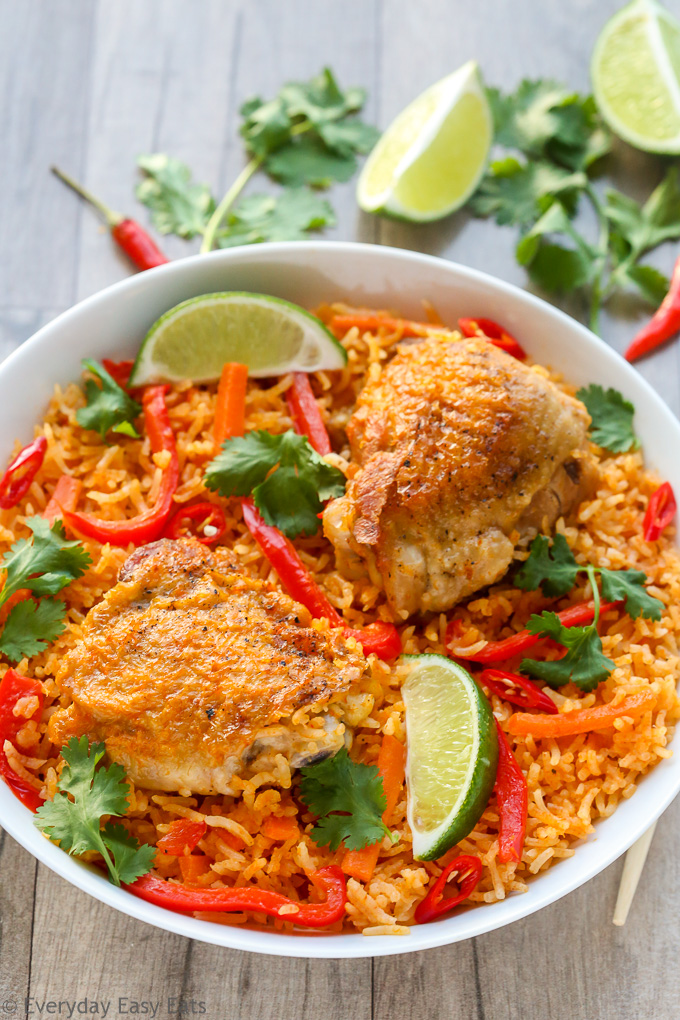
[49,540,366,794]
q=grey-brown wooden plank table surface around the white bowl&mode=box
[0,0,680,1020]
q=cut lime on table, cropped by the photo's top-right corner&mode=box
[590,0,680,154]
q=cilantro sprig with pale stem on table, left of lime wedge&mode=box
[137,67,378,251]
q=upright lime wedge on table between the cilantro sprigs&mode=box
[357,60,493,222]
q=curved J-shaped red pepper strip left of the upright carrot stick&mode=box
[64,386,179,546]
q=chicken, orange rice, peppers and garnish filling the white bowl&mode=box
[0,291,679,934]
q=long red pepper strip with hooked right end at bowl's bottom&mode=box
[125,865,347,928]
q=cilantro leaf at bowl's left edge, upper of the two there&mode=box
[0,517,92,606]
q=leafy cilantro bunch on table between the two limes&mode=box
[470,81,680,330]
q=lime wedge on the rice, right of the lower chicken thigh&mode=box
[402,655,499,861]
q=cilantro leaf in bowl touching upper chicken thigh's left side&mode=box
[205,429,345,539]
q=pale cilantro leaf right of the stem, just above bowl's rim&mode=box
[217,189,335,248]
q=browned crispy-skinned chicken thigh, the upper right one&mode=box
[323,338,589,618]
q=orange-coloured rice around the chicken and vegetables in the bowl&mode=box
[0,306,680,934]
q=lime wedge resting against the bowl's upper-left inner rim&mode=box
[129,291,347,386]
